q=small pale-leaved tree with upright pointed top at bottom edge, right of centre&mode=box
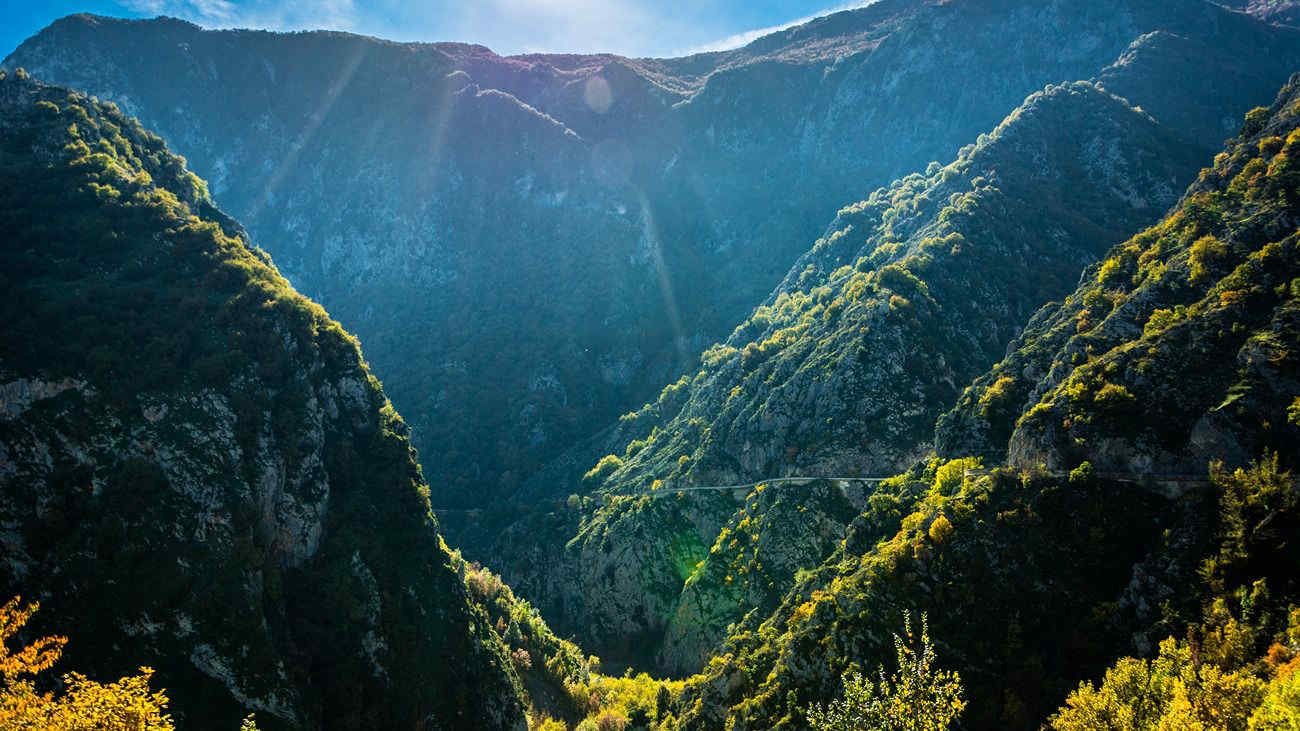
[807,613,966,731]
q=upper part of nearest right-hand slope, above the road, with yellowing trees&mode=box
[936,72,1300,475]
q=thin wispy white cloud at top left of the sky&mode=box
[120,0,360,30]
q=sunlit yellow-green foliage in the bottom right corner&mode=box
[1052,455,1300,731]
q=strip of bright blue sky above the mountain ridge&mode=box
[0,0,867,57]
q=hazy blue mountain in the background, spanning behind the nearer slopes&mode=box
[5,0,1297,517]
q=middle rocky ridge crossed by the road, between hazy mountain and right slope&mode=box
[495,82,1208,672]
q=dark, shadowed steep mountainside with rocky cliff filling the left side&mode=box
[0,74,524,728]
